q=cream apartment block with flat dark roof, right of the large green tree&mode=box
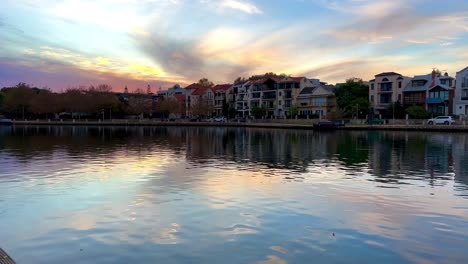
[369,72,411,114]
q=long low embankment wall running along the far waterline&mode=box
[9,120,468,132]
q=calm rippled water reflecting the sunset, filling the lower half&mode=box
[0,127,468,263]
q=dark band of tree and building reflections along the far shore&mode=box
[0,126,468,187]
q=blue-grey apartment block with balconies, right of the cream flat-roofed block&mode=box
[403,71,454,116]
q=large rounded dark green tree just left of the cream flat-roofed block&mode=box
[335,78,370,116]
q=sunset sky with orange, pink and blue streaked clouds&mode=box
[0,0,468,91]
